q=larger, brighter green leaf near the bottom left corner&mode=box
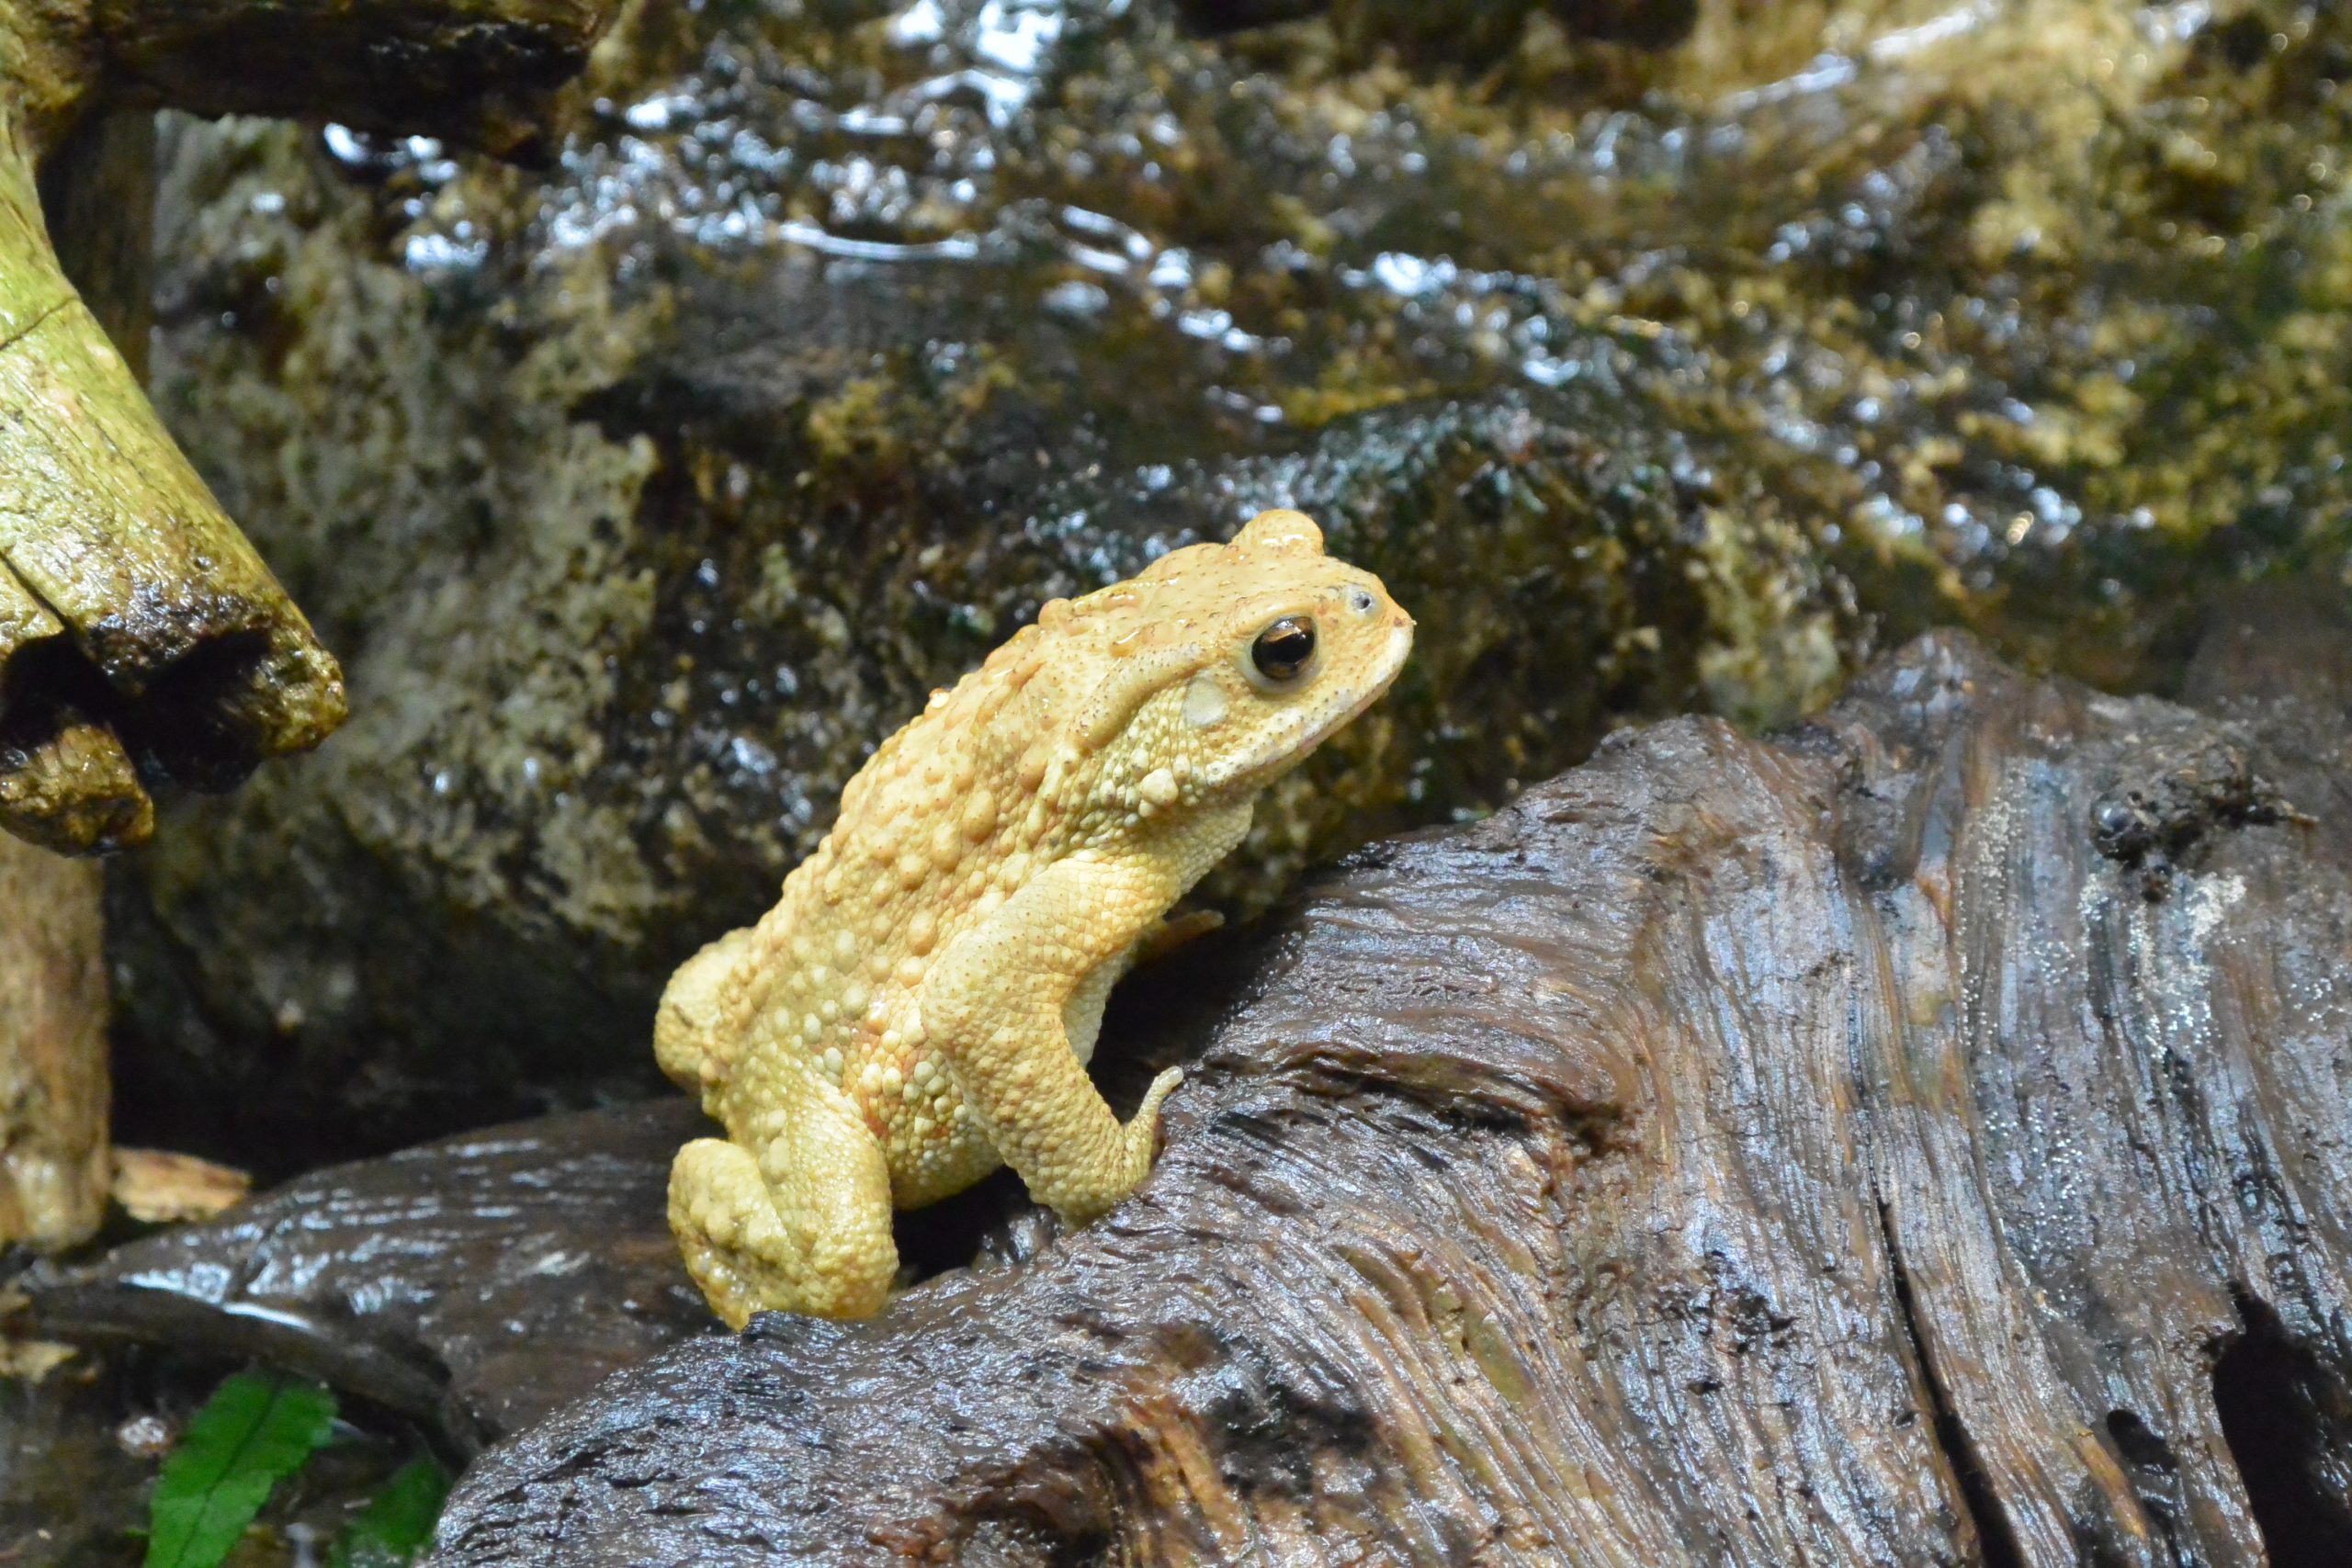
[146,1373,334,1568]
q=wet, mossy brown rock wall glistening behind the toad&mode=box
[113,0,2352,1170]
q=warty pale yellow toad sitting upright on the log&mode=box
[654,513,1414,1328]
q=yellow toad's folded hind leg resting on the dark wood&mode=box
[671,1069,899,1328]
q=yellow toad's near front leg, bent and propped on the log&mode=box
[922,856,1183,1224]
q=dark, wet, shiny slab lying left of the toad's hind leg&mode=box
[17,1096,715,1455]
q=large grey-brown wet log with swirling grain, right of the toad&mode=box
[430,632,2352,1568]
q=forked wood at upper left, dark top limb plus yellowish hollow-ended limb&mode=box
[0,0,618,853]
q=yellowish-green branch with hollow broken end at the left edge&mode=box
[0,107,344,849]
